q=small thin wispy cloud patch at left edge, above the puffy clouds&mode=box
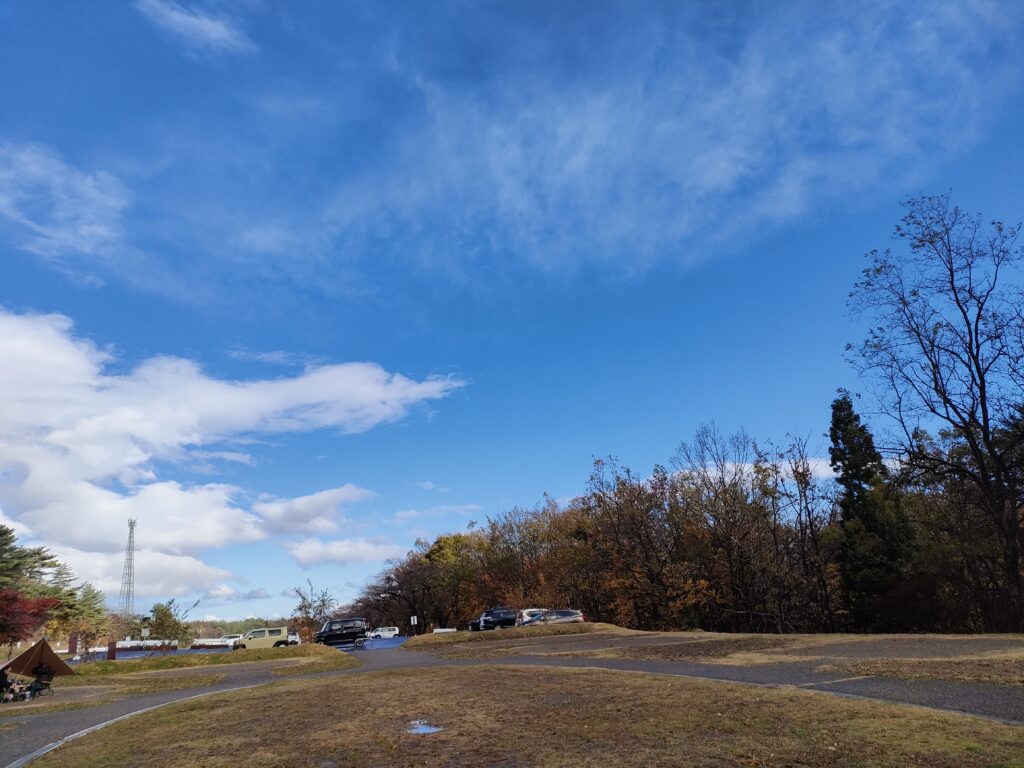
[0,143,130,272]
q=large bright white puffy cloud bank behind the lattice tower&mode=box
[0,310,462,594]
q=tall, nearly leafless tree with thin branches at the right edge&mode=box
[850,196,1024,629]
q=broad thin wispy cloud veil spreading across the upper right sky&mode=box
[315,2,1021,275]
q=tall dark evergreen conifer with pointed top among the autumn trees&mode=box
[828,390,914,630]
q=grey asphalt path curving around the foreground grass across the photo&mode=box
[0,647,1024,768]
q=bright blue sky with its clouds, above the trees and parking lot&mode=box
[0,0,1024,616]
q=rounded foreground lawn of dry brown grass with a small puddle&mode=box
[32,667,1024,768]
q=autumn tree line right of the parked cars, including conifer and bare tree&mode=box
[348,196,1024,632]
